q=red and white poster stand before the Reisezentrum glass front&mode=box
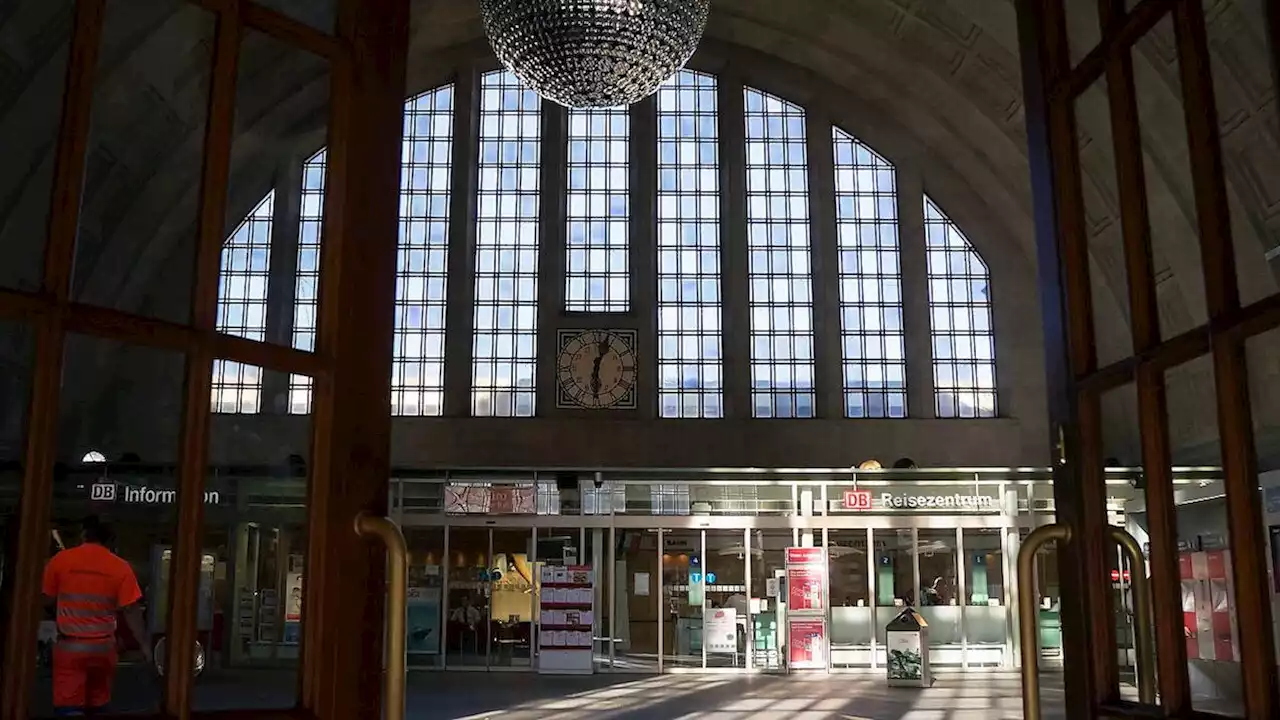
[786,547,829,670]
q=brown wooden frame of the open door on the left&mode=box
[0,0,408,720]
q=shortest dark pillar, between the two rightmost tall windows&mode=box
[896,163,937,418]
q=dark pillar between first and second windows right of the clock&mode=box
[716,72,751,418]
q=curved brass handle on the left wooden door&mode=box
[356,512,408,720]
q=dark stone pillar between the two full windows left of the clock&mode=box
[442,65,480,418]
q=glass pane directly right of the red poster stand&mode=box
[827,529,876,667]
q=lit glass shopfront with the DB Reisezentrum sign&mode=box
[392,470,1190,673]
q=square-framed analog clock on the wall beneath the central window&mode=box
[556,329,636,410]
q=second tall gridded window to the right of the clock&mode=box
[745,87,814,418]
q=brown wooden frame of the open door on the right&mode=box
[1016,0,1280,717]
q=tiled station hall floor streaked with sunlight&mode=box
[36,667,1065,720]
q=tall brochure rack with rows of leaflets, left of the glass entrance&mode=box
[538,565,595,675]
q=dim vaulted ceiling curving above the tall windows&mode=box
[0,0,1280,458]
